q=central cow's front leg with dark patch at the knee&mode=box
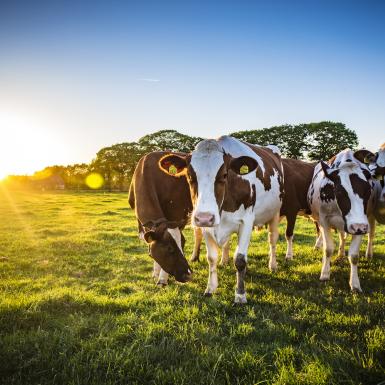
[234,220,253,303]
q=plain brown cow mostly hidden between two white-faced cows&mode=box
[281,158,318,259]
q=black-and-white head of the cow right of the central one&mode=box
[321,158,372,234]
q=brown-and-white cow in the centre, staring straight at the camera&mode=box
[159,136,283,303]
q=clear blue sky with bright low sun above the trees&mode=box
[0,0,385,178]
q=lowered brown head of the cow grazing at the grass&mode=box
[144,225,192,282]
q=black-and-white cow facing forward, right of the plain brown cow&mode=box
[308,149,372,292]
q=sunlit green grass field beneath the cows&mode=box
[0,190,385,385]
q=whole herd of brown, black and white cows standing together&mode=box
[129,136,385,303]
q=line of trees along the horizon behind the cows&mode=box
[4,121,358,191]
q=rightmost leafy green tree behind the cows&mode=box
[301,121,358,160]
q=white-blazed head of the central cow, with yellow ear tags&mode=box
[159,139,258,227]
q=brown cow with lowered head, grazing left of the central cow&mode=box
[129,152,201,285]
